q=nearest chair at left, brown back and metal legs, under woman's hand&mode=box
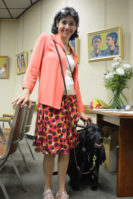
[0,105,27,199]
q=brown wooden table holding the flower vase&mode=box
[85,106,133,197]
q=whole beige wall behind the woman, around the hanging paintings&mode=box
[0,0,133,134]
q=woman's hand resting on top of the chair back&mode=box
[12,88,31,108]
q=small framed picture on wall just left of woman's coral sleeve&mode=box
[17,51,28,75]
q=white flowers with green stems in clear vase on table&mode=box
[104,57,133,109]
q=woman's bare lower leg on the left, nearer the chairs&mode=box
[43,155,55,190]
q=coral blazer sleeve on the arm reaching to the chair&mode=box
[23,34,46,92]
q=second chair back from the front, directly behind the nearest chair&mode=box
[25,101,36,133]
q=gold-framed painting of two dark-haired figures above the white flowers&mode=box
[87,27,123,62]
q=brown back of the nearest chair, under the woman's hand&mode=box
[0,104,27,160]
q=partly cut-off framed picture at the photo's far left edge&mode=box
[0,56,9,79]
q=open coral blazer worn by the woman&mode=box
[23,34,84,113]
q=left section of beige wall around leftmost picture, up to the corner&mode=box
[0,20,17,116]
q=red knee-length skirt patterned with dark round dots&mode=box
[33,95,79,154]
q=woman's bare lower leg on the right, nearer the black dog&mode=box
[58,153,69,192]
